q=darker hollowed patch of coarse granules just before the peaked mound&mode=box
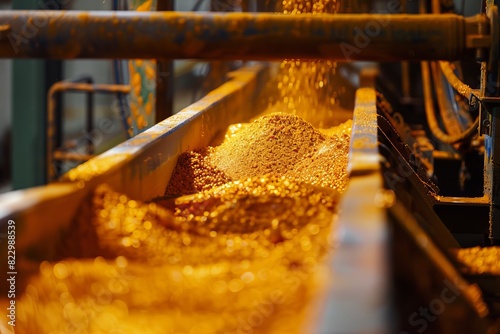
[175,176,339,235]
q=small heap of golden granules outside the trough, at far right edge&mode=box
[455,247,500,275]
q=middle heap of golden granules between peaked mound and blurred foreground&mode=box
[60,177,339,265]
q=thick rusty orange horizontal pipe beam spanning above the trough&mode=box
[0,11,466,61]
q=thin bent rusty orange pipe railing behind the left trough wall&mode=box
[46,81,130,183]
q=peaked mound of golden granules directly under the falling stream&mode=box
[166,113,352,195]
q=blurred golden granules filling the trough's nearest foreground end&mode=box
[16,257,311,333]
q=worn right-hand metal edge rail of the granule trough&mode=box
[305,88,394,334]
